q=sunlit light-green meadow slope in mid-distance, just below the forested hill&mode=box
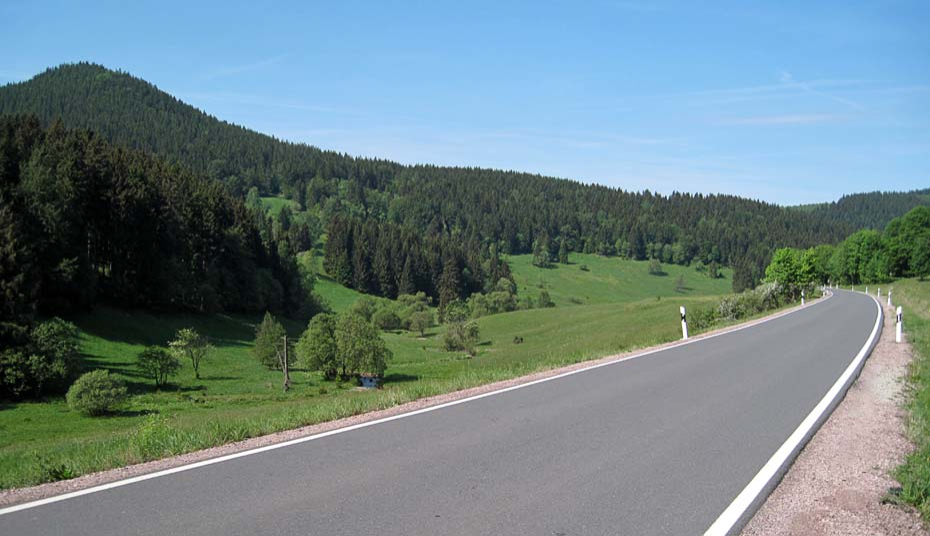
[507,253,733,306]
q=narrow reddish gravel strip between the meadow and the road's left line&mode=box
[0,298,826,507]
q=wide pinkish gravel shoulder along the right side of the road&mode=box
[743,305,930,536]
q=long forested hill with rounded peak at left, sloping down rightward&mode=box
[0,63,854,284]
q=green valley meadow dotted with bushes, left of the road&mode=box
[0,251,729,488]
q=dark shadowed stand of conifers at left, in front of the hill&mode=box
[0,116,316,344]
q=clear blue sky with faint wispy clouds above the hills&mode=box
[0,0,930,205]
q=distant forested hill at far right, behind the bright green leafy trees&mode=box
[792,188,930,230]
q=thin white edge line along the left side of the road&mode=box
[0,294,833,516]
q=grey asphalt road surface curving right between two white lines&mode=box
[0,293,878,536]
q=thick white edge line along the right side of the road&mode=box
[704,295,883,536]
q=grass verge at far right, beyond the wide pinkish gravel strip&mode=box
[892,279,930,522]
